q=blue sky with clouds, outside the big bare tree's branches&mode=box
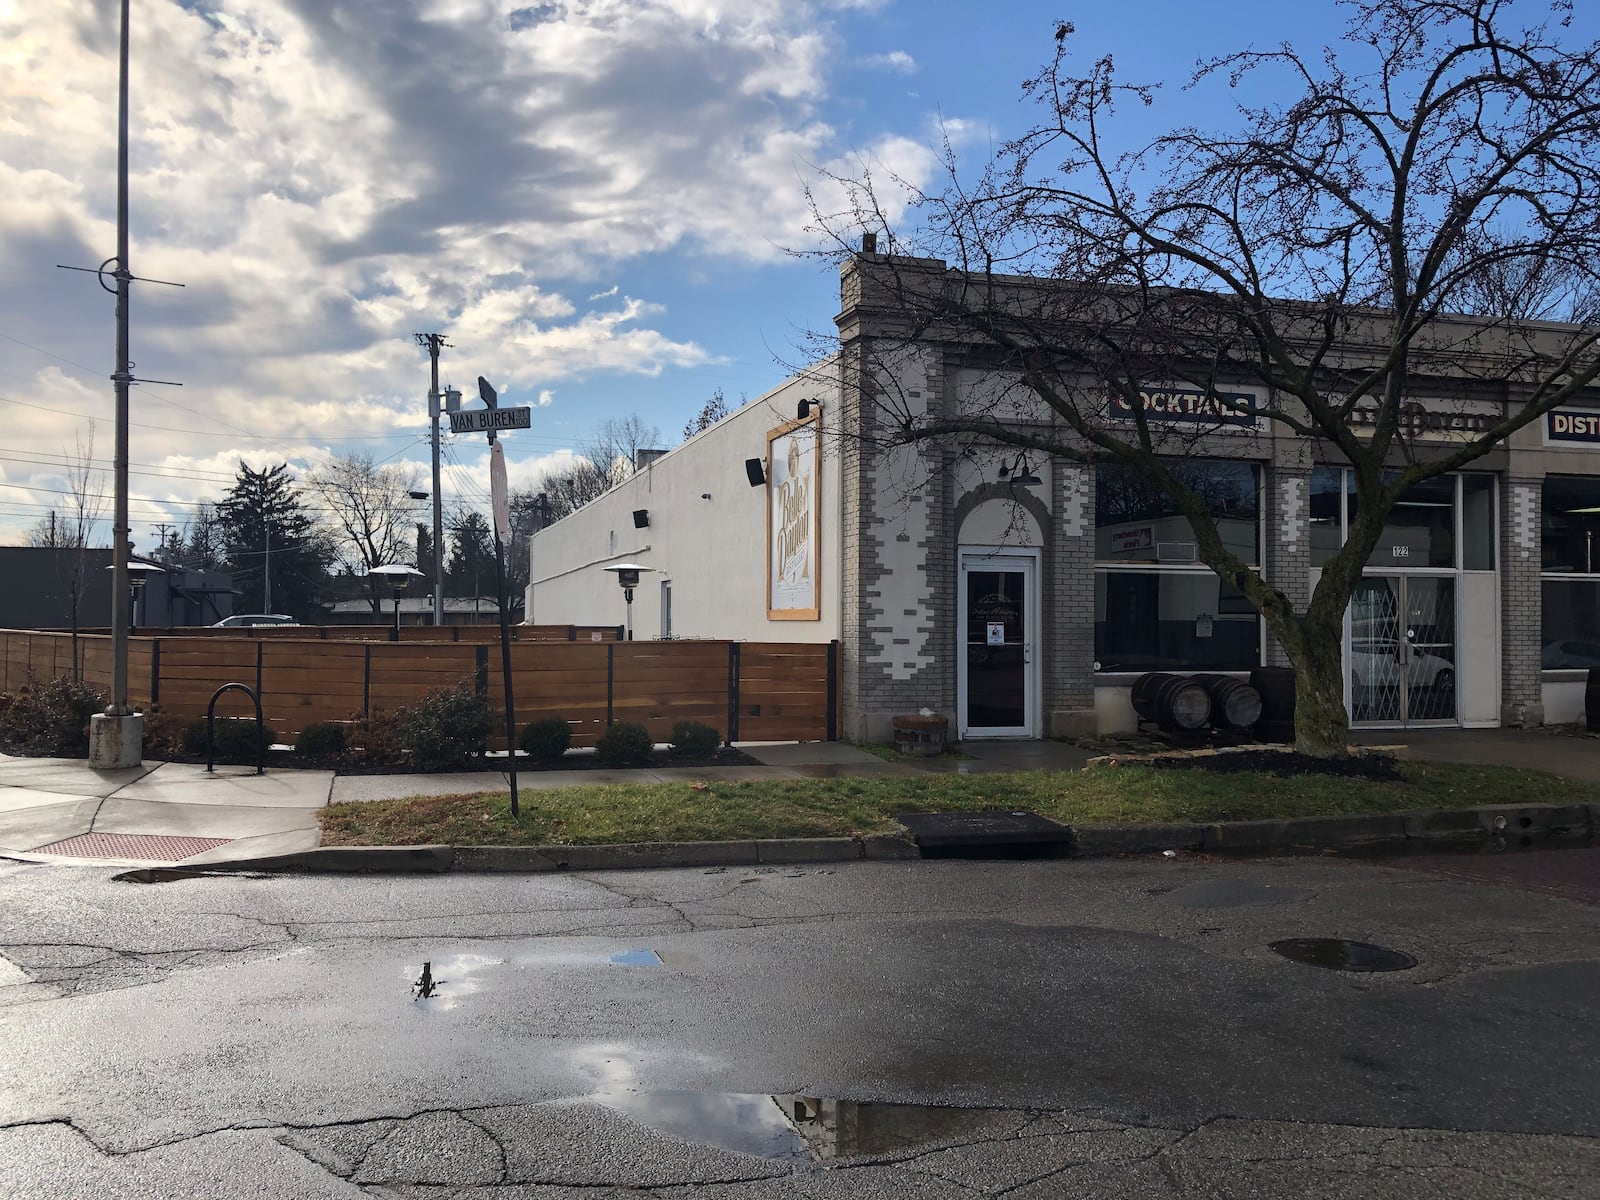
[0,0,1574,552]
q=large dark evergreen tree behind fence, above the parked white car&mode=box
[216,462,334,622]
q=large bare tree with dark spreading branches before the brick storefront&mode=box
[818,0,1600,755]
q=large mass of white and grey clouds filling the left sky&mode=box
[0,0,933,536]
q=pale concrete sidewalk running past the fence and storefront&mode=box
[0,730,1600,867]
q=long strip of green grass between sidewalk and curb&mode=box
[312,762,1600,846]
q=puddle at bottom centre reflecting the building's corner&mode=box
[587,1091,1018,1160]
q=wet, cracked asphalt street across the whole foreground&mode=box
[0,850,1600,1200]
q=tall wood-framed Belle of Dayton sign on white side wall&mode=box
[766,410,822,621]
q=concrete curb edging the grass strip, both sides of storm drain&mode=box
[178,805,1600,875]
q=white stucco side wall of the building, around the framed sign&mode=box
[525,363,842,642]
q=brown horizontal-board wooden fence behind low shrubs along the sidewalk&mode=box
[0,626,838,747]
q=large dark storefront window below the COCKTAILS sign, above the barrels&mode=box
[1094,459,1261,672]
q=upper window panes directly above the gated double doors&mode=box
[1310,467,1494,571]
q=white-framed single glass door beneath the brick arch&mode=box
[958,554,1037,738]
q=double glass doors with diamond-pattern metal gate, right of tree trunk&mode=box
[1347,574,1459,725]
